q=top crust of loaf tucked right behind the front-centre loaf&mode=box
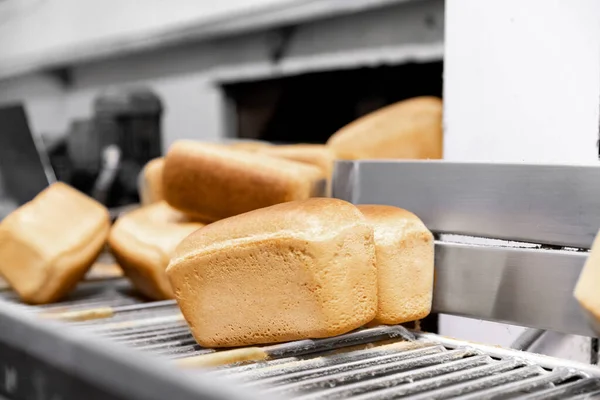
[357,204,433,244]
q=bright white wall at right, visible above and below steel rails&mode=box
[440,0,600,362]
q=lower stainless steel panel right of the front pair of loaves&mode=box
[433,242,595,336]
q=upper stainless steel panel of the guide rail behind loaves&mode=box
[333,161,600,248]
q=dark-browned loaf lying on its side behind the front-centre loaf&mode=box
[163,141,324,221]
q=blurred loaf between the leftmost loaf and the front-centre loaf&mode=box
[109,201,204,300]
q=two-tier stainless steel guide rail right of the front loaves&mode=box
[332,161,600,336]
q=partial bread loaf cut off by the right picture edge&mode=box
[574,234,600,323]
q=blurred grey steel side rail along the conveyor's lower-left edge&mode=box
[0,290,266,400]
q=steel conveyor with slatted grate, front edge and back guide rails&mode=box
[0,161,600,399]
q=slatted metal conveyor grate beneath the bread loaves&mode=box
[0,280,600,400]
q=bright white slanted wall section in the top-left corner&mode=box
[0,0,298,70]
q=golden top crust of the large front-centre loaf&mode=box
[169,198,368,268]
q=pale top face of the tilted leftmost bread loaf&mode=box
[0,182,110,258]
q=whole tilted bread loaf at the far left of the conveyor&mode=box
[0,182,110,304]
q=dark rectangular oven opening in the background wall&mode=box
[222,61,443,143]
